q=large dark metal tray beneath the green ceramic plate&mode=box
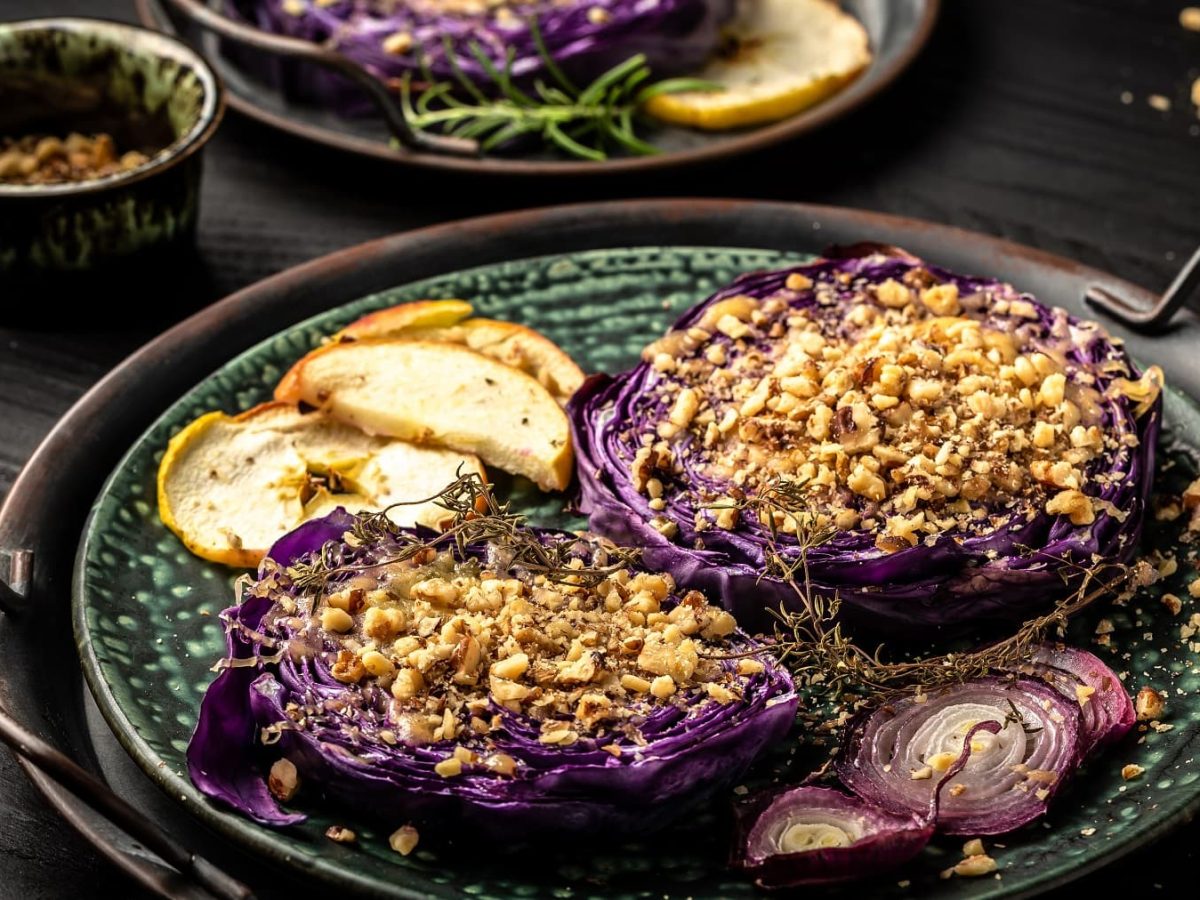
[0,200,1200,895]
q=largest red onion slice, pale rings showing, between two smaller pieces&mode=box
[838,677,1080,834]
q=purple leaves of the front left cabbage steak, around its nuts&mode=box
[187,511,797,841]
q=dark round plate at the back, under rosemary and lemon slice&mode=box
[134,0,941,175]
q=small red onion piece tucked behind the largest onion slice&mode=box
[1018,643,1138,756]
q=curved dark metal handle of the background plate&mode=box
[160,0,479,156]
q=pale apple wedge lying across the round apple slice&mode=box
[275,338,575,491]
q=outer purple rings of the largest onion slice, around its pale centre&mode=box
[835,676,1084,835]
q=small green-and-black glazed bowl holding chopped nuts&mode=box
[0,18,224,283]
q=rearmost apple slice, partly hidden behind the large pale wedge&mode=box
[334,300,583,406]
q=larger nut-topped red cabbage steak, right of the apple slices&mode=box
[570,252,1162,637]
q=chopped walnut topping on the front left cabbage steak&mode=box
[267,552,764,790]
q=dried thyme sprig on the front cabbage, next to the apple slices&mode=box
[288,469,641,592]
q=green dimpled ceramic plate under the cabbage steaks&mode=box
[74,247,1200,899]
